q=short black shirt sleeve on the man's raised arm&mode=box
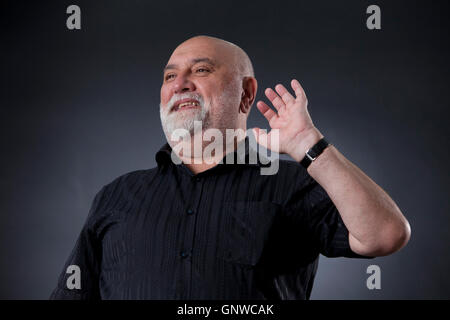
[292,177,374,259]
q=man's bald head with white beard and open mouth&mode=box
[160,36,257,144]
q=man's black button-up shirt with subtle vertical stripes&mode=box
[51,138,368,299]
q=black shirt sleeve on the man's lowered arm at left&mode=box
[50,189,104,300]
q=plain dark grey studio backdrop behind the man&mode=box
[0,0,450,299]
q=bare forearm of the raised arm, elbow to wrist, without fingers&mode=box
[291,128,411,256]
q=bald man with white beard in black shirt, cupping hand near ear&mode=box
[51,36,410,299]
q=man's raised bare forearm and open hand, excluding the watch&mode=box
[254,80,411,256]
